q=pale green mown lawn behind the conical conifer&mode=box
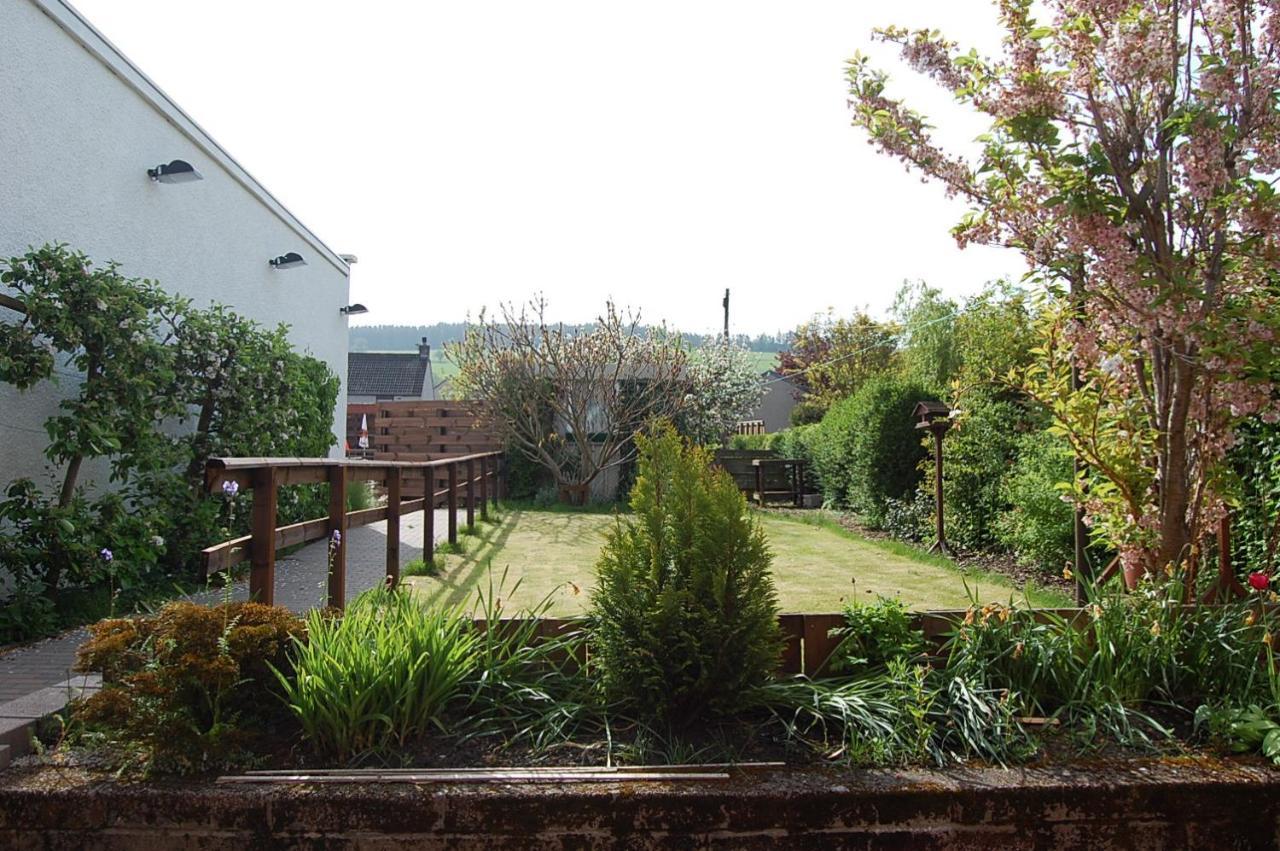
[406,507,1069,614]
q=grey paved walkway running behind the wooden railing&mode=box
[0,509,463,703]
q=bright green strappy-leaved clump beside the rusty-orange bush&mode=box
[278,587,477,761]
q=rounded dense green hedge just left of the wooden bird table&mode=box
[809,375,931,526]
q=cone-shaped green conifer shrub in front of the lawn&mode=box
[591,422,781,726]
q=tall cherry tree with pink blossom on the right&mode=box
[849,0,1280,578]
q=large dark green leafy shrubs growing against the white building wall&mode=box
[0,244,339,641]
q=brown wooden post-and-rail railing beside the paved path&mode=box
[204,452,503,609]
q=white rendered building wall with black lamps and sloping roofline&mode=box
[0,0,349,484]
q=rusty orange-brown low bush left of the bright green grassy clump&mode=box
[74,601,306,773]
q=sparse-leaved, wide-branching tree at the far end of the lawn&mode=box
[449,297,687,499]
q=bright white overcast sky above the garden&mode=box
[67,0,1025,334]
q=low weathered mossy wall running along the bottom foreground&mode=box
[0,760,1280,851]
